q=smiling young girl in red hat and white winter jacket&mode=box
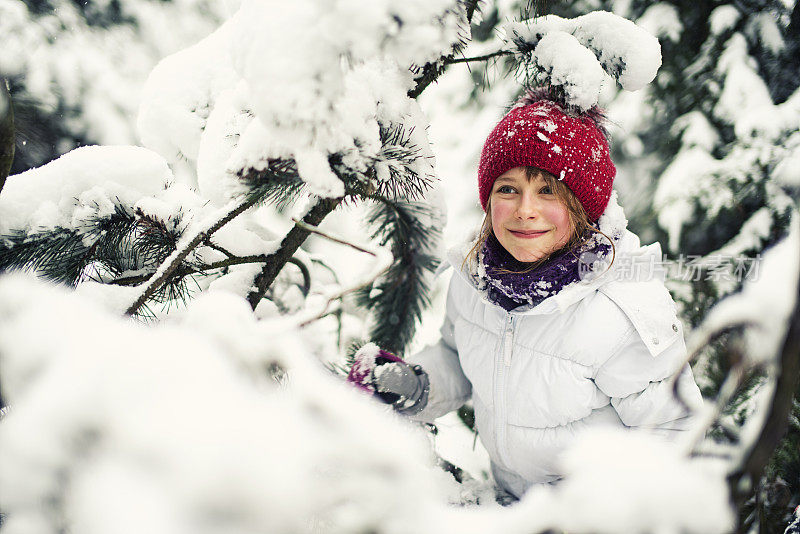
[349,91,702,497]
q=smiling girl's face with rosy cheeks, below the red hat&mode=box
[490,167,572,263]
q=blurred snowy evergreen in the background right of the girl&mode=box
[608,1,800,532]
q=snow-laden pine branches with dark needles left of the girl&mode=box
[0,2,468,352]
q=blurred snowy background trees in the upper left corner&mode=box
[0,0,235,173]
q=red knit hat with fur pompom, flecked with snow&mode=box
[478,92,617,221]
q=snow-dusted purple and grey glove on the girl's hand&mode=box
[347,343,429,415]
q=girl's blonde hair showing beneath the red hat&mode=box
[461,167,617,273]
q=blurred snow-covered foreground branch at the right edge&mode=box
[676,218,800,524]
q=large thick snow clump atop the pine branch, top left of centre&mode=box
[139,0,465,203]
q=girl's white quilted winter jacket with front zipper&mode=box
[408,200,702,497]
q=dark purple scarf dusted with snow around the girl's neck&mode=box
[478,234,610,311]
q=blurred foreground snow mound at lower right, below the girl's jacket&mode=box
[519,430,734,534]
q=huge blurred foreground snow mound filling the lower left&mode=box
[0,274,455,534]
